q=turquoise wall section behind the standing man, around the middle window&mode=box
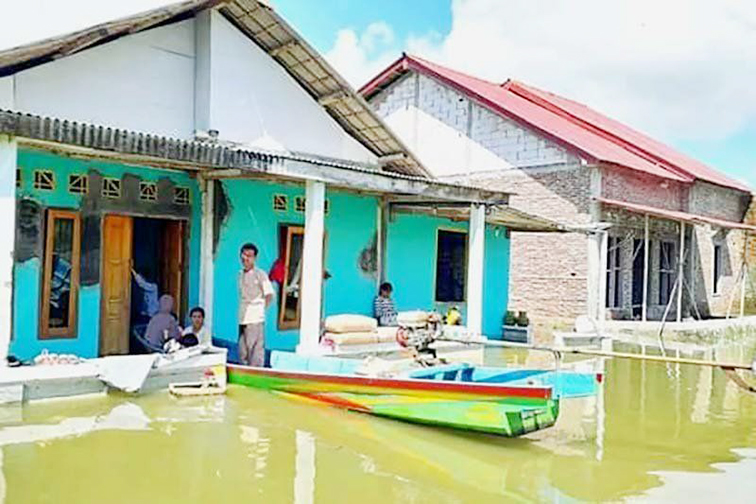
[213,180,377,350]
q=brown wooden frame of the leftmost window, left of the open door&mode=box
[39,209,81,339]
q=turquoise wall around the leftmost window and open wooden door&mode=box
[10,150,202,359]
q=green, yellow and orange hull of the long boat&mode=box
[228,365,559,437]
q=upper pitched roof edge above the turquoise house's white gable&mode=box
[0,0,430,177]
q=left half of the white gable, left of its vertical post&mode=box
[14,20,194,138]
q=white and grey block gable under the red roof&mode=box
[371,72,576,177]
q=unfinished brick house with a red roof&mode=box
[360,55,756,320]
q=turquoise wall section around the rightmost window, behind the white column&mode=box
[386,214,509,338]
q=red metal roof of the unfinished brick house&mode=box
[360,55,750,192]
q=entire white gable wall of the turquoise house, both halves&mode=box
[6,11,375,162]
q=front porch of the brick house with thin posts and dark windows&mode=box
[598,198,756,327]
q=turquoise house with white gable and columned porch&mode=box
[0,0,553,360]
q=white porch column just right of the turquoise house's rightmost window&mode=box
[467,204,486,334]
